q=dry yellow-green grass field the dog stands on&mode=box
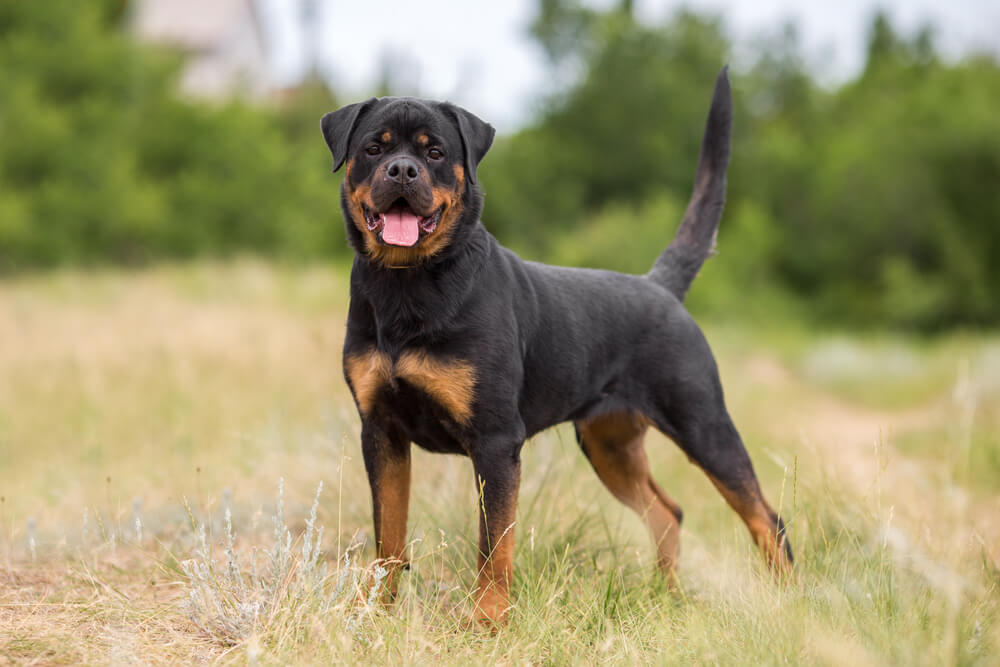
[0,261,1000,666]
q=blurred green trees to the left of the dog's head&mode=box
[0,0,346,272]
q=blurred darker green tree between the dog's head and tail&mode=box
[483,7,728,252]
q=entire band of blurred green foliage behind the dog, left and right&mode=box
[0,0,1000,331]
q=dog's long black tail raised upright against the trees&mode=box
[648,66,733,301]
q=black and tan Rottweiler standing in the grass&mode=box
[322,70,792,622]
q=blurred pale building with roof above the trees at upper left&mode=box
[130,0,271,98]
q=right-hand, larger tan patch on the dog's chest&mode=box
[395,351,476,424]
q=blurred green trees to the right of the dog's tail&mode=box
[752,15,1000,329]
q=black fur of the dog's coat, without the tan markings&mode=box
[323,70,790,616]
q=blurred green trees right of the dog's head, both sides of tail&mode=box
[482,0,1000,330]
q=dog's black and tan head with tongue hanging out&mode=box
[322,97,494,268]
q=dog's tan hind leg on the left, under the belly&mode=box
[575,412,682,576]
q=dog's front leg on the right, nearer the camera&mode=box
[473,448,521,626]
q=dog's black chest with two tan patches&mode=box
[344,347,476,451]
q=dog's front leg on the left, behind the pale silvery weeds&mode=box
[361,420,410,602]
